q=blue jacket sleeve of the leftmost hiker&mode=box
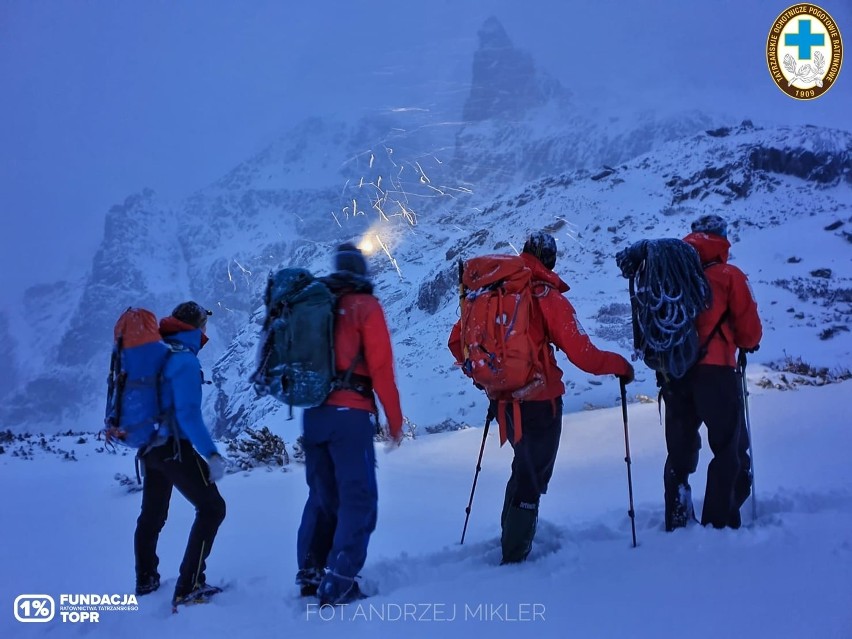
[169,353,217,458]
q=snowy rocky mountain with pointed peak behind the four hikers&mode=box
[0,19,852,434]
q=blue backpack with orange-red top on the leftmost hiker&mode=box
[104,308,172,448]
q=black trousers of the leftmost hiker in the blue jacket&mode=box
[134,439,225,595]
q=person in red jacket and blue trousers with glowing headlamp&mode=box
[296,243,403,604]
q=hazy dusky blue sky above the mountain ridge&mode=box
[0,0,852,305]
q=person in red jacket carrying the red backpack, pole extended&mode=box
[448,232,633,564]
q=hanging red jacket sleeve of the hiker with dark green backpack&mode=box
[361,302,402,437]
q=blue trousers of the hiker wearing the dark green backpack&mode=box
[296,406,378,578]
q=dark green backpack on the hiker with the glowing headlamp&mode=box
[252,268,337,408]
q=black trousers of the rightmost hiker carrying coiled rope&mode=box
[662,365,751,528]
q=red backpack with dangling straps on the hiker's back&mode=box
[461,255,545,442]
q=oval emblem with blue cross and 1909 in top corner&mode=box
[766,3,843,100]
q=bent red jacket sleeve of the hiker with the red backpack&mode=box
[537,289,630,375]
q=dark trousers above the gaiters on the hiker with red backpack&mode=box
[505,397,562,506]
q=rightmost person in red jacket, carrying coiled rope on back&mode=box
[659,215,763,531]
